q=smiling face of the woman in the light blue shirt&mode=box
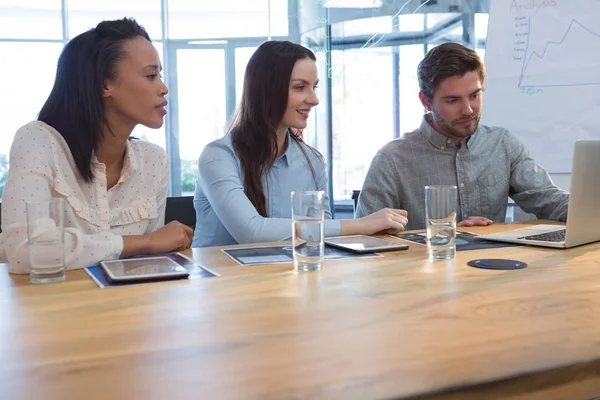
[281,57,319,129]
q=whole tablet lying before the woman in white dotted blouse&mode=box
[100,257,190,282]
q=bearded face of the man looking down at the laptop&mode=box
[419,72,483,144]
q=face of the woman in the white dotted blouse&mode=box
[104,37,169,133]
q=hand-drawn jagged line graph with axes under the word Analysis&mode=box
[518,17,600,88]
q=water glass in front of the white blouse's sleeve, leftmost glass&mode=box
[26,199,66,283]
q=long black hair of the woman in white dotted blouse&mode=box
[38,18,150,182]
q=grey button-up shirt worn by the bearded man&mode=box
[356,114,569,229]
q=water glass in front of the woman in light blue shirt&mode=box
[292,190,325,271]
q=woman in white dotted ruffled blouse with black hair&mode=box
[0,18,193,273]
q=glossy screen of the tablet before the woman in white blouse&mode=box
[102,257,187,278]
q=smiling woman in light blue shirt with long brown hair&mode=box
[193,41,407,247]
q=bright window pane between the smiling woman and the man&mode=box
[331,47,394,199]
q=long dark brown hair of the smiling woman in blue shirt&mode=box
[229,41,316,217]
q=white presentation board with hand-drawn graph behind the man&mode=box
[482,0,600,173]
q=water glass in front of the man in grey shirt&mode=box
[425,186,457,260]
